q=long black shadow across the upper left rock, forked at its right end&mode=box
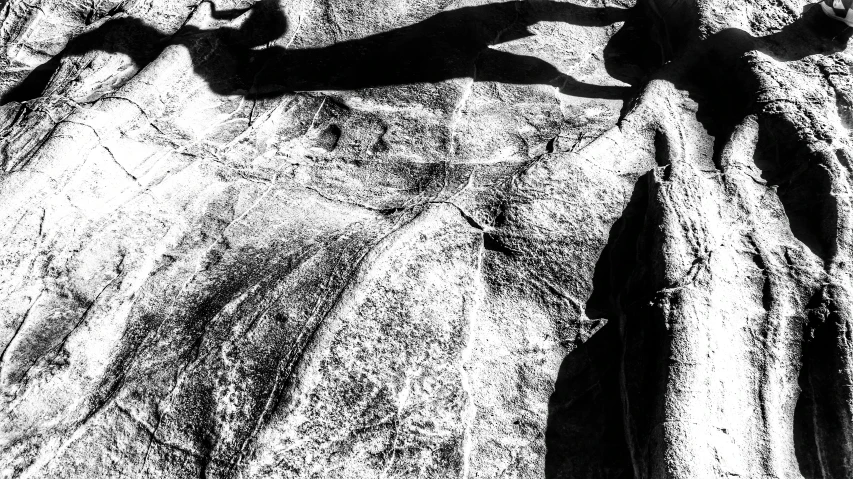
[0,0,630,104]
